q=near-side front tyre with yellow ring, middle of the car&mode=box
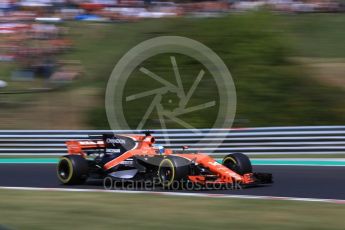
[158,156,190,189]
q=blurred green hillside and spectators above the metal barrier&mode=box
[0,0,345,129]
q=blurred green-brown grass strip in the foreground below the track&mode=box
[0,190,345,230]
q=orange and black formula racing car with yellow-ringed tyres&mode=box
[57,132,272,187]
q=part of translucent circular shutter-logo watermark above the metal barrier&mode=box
[105,36,236,147]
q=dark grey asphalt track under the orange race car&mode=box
[0,164,345,200]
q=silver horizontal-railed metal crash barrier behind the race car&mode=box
[0,126,345,156]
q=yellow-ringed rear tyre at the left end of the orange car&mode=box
[57,155,88,185]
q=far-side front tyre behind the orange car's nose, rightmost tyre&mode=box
[222,153,253,175]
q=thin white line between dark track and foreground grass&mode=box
[0,186,345,204]
